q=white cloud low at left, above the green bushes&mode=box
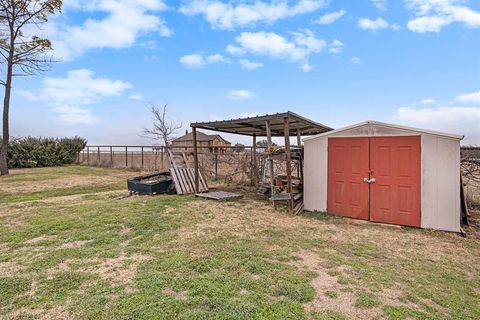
[16,69,132,124]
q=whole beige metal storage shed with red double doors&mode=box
[304,121,463,232]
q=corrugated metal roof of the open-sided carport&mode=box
[191,111,333,137]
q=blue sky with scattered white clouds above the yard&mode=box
[11,0,480,145]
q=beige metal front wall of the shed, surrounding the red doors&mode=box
[304,124,460,232]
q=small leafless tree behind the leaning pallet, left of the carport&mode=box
[142,104,182,147]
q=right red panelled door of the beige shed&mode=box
[370,136,420,227]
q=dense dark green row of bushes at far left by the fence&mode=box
[0,137,87,168]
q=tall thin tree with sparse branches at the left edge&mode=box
[0,0,62,175]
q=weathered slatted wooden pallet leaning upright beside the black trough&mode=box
[168,150,208,194]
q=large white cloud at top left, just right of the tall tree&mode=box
[48,0,173,60]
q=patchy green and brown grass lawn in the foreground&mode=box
[0,166,480,319]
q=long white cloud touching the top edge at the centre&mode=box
[180,0,327,30]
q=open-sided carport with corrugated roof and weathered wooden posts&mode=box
[190,111,333,209]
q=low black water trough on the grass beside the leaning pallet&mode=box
[127,171,175,195]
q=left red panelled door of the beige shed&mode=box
[327,138,369,220]
